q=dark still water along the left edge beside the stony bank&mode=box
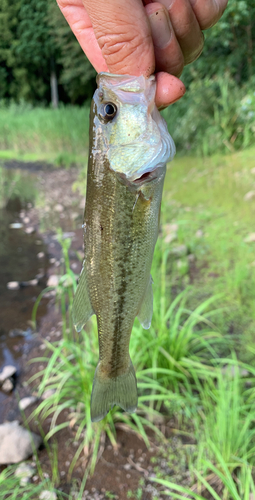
[0,168,49,422]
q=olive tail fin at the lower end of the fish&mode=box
[90,360,137,422]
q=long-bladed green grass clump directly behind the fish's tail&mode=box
[28,232,228,475]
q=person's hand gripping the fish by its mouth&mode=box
[57,0,228,108]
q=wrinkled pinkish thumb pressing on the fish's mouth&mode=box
[83,0,155,76]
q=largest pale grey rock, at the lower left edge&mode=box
[0,420,42,464]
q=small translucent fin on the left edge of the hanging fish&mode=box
[73,264,94,332]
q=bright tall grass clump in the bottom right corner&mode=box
[152,357,255,500]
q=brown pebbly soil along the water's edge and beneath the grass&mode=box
[2,162,195,500]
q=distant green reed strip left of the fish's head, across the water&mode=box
[0,103,89,165]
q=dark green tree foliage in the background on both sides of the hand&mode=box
[0,0,255,104]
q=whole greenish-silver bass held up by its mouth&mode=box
[73,73,175,422]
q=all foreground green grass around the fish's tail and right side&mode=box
[26,143,255,494]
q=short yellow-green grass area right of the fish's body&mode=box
[162,148,255,352]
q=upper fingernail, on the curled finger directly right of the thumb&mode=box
[149,9,172,49]
